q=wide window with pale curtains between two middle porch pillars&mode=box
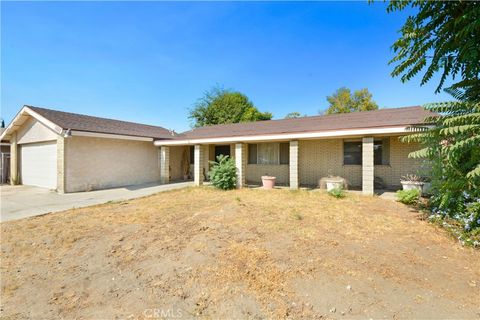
[248,143,290,165]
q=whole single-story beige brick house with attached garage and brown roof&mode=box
[1,106,434,194]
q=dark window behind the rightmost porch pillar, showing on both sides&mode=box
[343,138,390,165]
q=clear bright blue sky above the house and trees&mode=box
[1,1,449,132]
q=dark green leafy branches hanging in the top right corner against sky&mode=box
[387,0,480,101]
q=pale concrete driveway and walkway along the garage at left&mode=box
[0,182,193,222]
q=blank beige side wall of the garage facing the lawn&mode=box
[65,136,160,192]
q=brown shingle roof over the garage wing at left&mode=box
[26,106,173,139]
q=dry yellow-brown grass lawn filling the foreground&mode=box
[0,187,480,319]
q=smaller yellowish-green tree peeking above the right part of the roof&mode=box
[325,87,378,114]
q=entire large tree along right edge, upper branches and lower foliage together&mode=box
[388,0,480,238]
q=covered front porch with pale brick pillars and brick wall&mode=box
[160,135,420,195]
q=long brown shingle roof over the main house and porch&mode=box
[176,106,435,139]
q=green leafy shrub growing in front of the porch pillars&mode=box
[209,155,237,190]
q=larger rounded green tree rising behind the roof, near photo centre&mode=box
[189,86,272,127]
